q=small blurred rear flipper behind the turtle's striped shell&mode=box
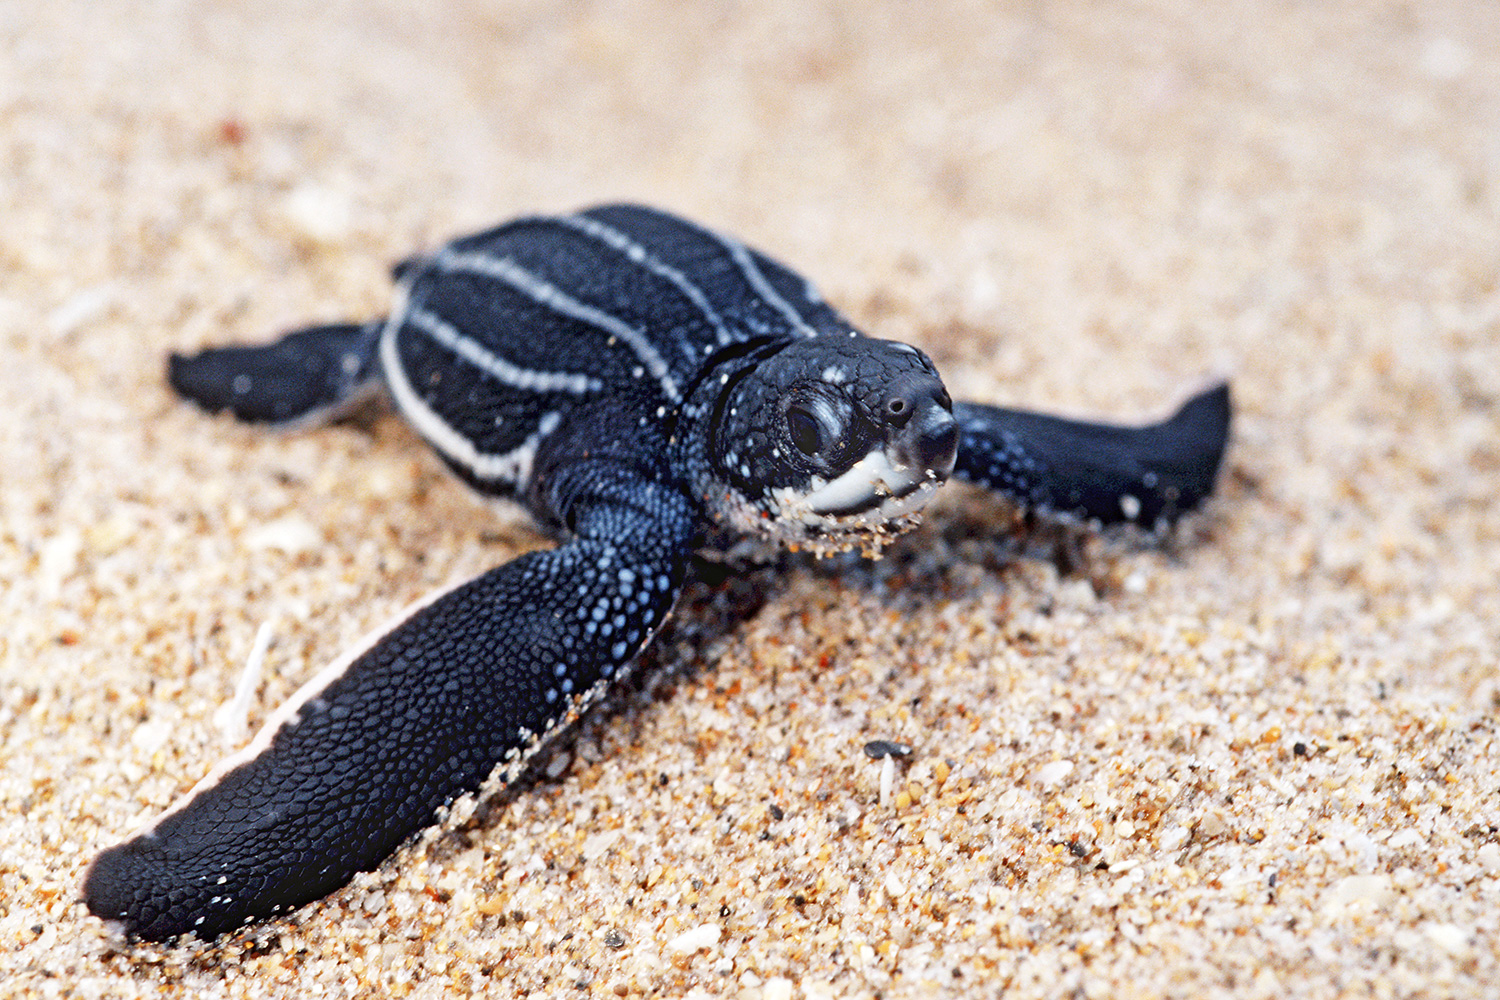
[167,321,381,424]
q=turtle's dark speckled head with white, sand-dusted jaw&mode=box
[710,336,959,553]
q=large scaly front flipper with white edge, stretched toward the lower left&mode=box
[84,463,693,940]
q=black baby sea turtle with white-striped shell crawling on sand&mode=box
[84,205,1230,940]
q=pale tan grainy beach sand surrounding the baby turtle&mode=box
[0,0,1500,1000]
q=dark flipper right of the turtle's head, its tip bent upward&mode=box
[954,382,1230,529]
